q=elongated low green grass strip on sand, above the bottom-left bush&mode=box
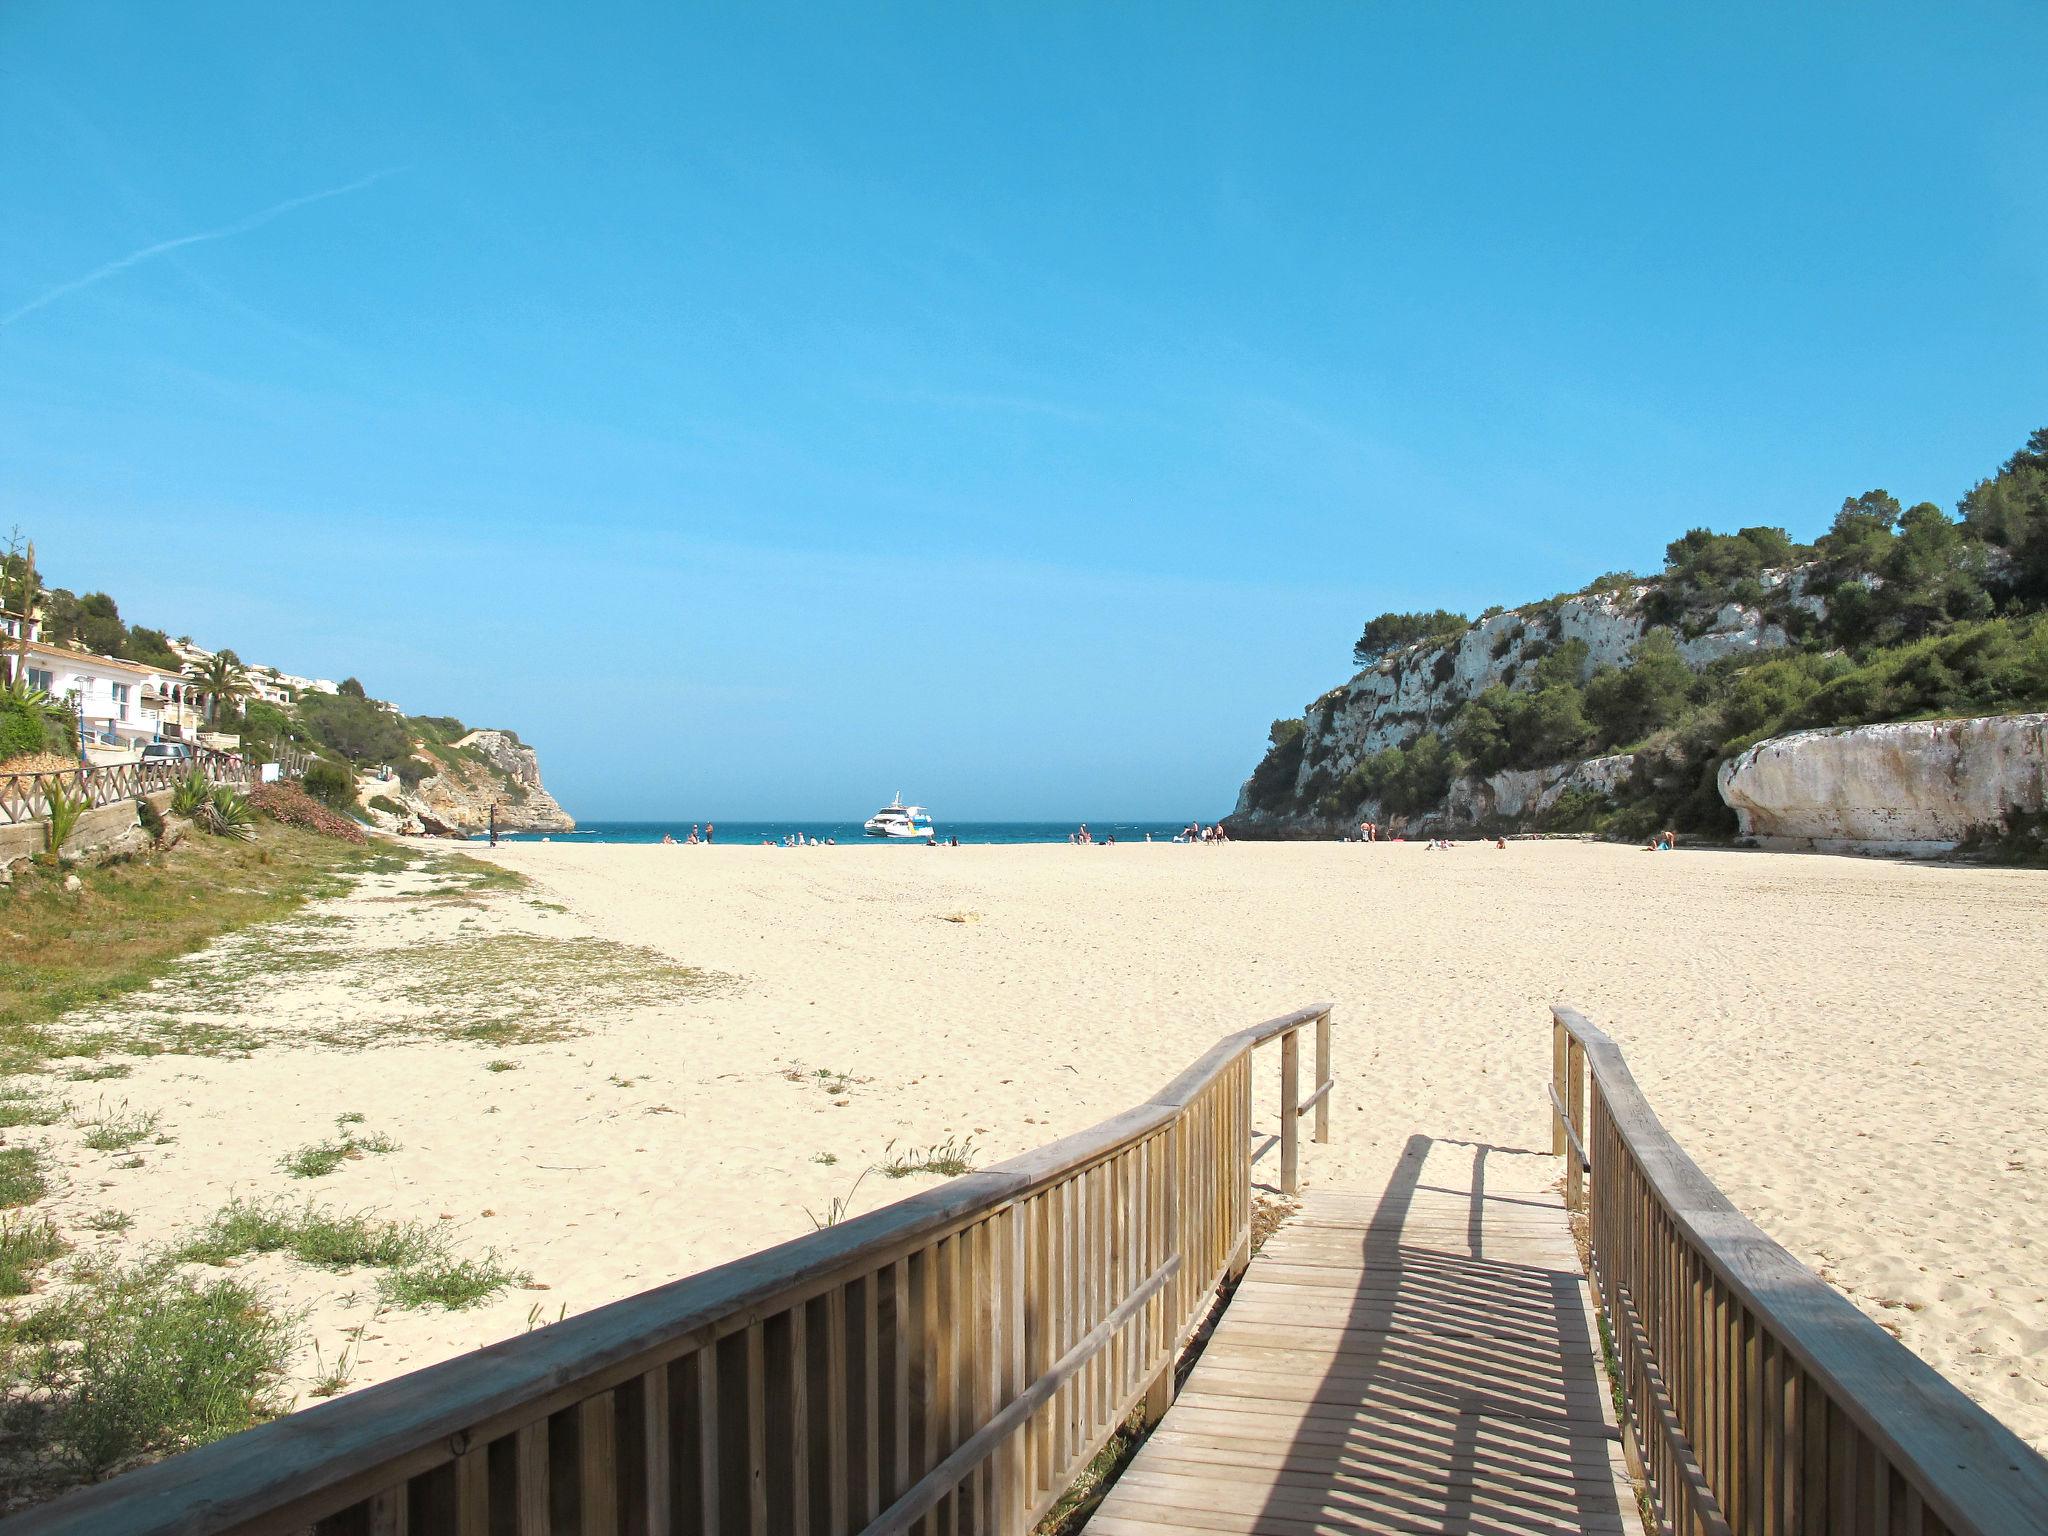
[170,1200,530,1311]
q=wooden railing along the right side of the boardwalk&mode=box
[1550,1008,2048,1536]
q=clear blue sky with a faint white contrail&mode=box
[0,0,2048,819]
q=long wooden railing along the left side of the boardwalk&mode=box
[4,1006,1329,1536]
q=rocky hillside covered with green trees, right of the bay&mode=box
[1231,428,2048,838]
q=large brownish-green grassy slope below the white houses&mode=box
[0,821,410,1073]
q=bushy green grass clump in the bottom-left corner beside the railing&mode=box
[0,1260,297,1497]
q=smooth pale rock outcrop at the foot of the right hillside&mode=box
[1718,715,2048,854]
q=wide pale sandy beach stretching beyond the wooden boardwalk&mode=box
[19,840,2048,1450]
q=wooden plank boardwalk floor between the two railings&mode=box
[1087,1157,1640,1536]
